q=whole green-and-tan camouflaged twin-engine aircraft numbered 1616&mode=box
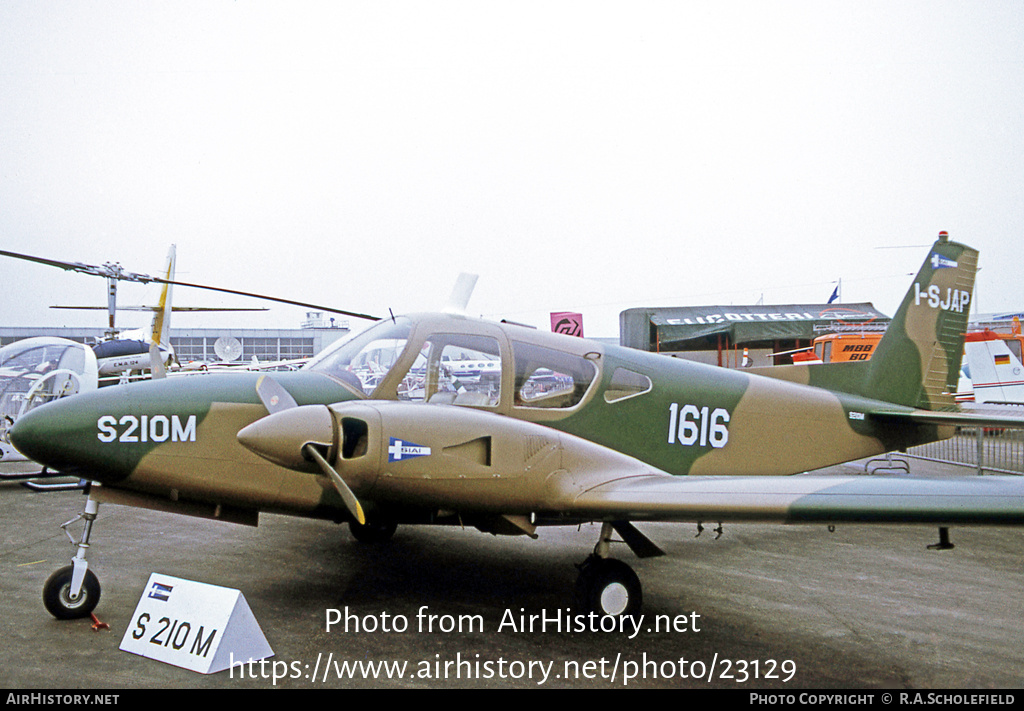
[10,234,1024,617]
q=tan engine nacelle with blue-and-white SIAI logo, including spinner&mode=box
[239,401,660,513]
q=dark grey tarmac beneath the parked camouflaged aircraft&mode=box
[0,461,1024,692]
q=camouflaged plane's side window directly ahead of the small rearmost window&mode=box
[512,342,597,409]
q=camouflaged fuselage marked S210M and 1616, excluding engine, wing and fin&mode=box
[11,315,935,517]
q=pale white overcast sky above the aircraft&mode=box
[0,0,1024,336]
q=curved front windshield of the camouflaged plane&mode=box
[304,318,412,395]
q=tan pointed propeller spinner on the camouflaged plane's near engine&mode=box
[238,405,337,470]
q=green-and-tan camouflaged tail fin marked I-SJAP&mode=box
[859,233,978,410]
